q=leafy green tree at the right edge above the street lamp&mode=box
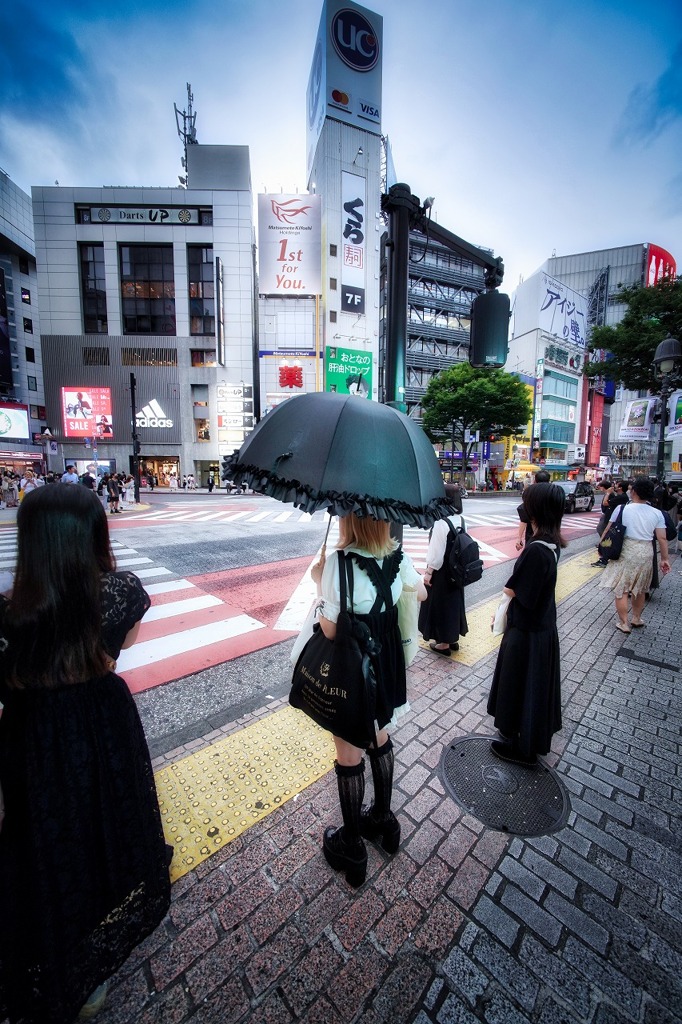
[585,278,682,392]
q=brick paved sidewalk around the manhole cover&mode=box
[93,560,682,1024]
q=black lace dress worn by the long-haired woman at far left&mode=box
[0,572,170,1024]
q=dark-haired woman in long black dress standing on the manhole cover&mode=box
[487,483,566,765]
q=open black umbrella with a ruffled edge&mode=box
[223,391,455,526]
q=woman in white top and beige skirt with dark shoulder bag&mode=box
[599,476,670,633]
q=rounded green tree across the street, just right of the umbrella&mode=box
[422,362,532,465]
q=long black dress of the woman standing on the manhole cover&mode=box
[487,541,561,756]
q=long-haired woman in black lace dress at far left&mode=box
[0,483,170,1024]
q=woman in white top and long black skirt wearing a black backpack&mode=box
[419,483,469,657]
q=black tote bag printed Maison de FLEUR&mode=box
[289,551,380,749]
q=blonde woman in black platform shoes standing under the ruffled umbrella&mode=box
[312,513,426,887]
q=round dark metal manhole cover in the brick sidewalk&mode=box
[440,736,570,836]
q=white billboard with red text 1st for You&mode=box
[258,195,322,297]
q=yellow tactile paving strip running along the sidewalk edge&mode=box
[155,551,599,882]
